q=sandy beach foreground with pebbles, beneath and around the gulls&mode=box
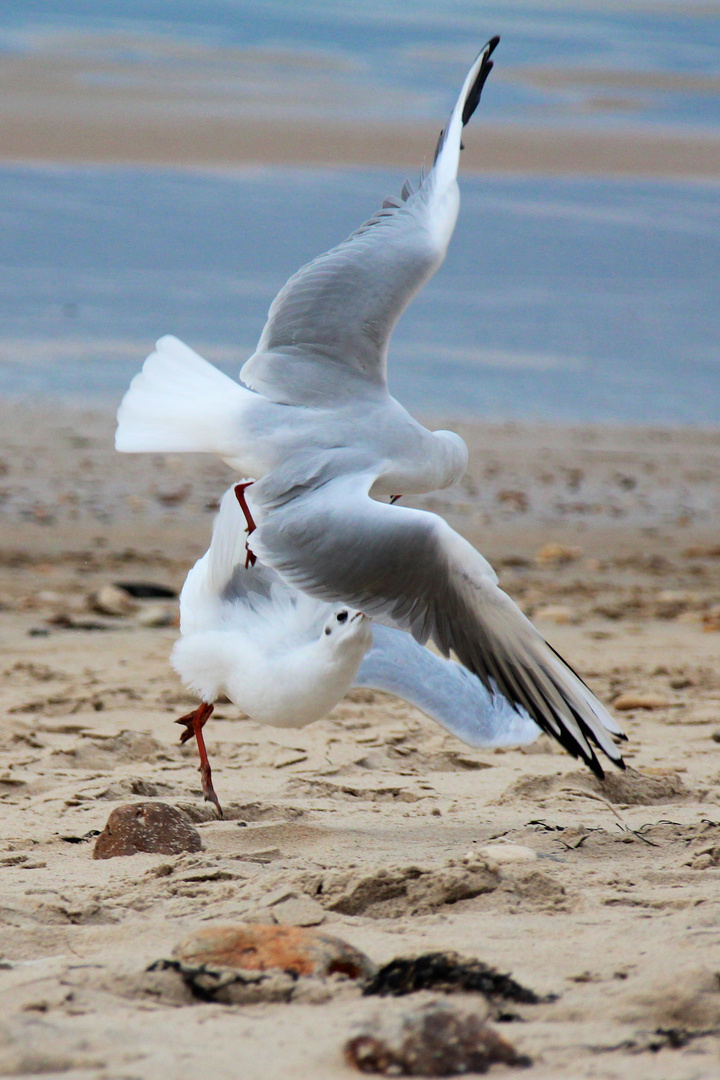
[0,404,720,1080]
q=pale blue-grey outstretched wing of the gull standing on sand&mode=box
[354,623,540,746]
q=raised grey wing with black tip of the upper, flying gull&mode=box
[240,38,499,405]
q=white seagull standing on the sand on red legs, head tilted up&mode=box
[172,484,540,816]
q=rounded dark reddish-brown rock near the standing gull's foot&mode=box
[93,802,203,859]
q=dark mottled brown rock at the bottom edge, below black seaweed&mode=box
[344,1001,532,1077]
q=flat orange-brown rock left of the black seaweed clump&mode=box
[173,923,376,980]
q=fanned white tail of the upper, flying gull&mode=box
[116,335,255,457]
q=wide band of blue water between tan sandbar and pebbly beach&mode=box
[0,168,720,424]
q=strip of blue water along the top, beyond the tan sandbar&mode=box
[0,0,720,132]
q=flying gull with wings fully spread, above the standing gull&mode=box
[116,38,625,778]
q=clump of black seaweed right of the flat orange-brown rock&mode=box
[363,951,548,1005]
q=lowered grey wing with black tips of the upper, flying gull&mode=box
[249,475,623,777]
